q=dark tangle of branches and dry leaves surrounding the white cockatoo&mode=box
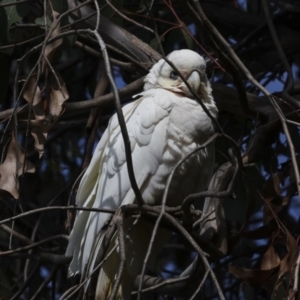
[0,0,300,300]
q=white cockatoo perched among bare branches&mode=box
[66,50,217,299]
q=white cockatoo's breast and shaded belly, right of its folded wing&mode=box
[143,100,214,206]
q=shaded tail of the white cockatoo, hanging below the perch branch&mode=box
[87,218,171,300]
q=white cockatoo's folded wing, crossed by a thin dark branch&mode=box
[66,90,173,274]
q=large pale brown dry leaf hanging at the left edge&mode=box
[0,133,35,199]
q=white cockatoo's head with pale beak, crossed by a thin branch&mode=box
[144,49,212,101]
